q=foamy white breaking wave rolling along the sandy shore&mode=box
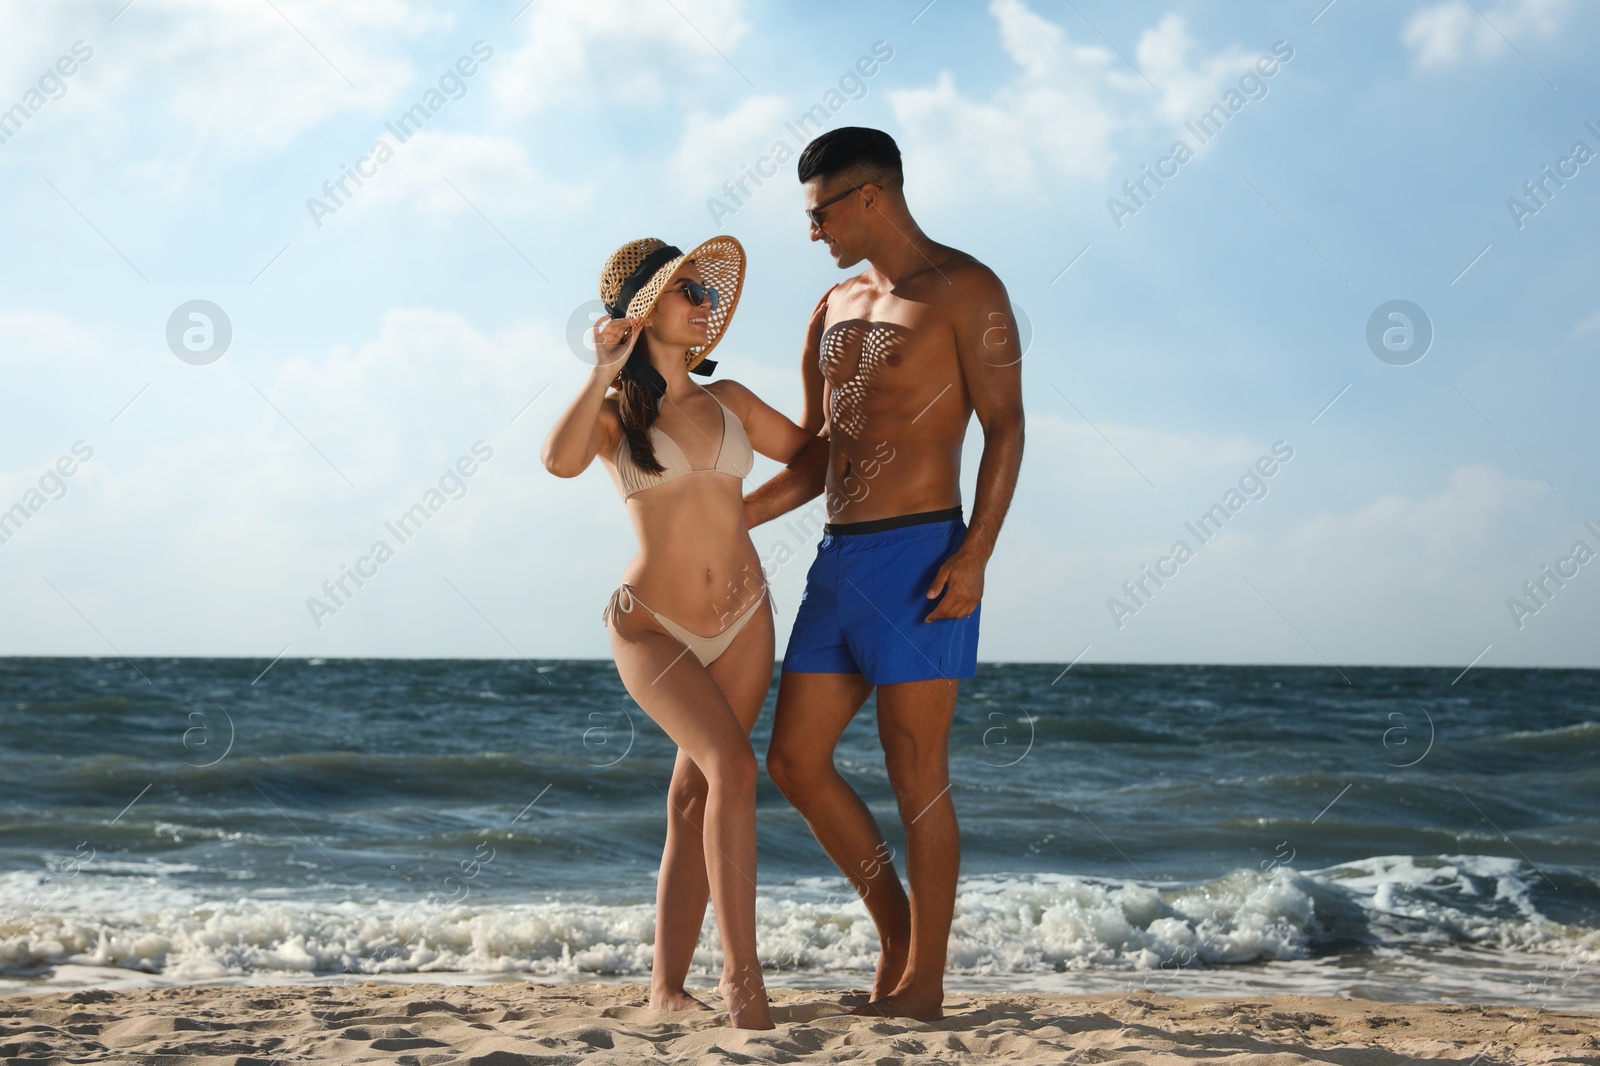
[0,856,1600,980]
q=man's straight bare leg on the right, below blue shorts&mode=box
[851,680,962,1021]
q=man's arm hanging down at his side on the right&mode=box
[928,267,1022,621]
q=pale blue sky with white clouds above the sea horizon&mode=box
[0,0,1600,669]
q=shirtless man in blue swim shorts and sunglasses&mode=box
[746,126,1022,1020]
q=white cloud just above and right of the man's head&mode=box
[890,0,1273,198]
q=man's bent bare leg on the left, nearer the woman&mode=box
[766,671,912,1000]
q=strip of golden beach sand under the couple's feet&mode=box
[0,983,1600,1066]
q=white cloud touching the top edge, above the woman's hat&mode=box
[493,0,750,117]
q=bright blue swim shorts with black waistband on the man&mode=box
[784,506,982,685]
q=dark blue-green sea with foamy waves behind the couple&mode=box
[0,658,1600,1010]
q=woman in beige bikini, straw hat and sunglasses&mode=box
[544,237,813,1029]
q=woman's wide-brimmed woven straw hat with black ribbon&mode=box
[600,237,744,376]
